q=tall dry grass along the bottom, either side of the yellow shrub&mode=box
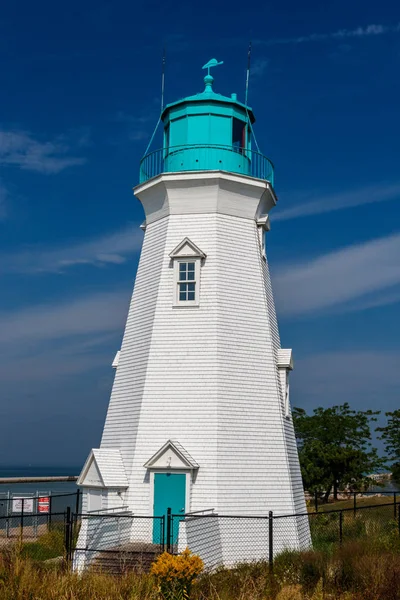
[0,538,400,600]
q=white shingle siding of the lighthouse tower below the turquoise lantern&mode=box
[77,172,309,558]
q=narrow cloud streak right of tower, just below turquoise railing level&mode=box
[273,183,400,221]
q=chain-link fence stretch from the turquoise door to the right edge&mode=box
[170,502,400,568]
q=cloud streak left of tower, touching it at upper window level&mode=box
[0,226,143,275]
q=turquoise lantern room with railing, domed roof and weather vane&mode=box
[140,59,273,183]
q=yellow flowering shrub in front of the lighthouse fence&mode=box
[151,548,204,600]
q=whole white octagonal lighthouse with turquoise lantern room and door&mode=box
[78,61,310,565]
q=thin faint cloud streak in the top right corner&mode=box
[257,23,400,46]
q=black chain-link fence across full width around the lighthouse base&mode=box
[0,494,400,574]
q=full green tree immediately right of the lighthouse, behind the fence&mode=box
[293,403,385,500]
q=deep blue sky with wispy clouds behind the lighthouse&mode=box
[0,0,400,465]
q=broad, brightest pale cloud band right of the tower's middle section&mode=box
[274,234,400,316]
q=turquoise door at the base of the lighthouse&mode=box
[153,473,186,544]
